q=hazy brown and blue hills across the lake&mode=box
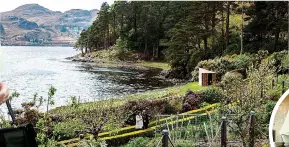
[0,4,98,46]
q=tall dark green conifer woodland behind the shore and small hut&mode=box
[75,1,288,76]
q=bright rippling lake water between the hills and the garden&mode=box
[0,47,171,116]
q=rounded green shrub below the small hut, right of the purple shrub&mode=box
[202,88,225,104]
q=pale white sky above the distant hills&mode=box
[0,0,114,12]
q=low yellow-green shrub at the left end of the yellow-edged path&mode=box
[53,119,85,140]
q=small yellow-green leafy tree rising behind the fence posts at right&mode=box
[222,60,275,146]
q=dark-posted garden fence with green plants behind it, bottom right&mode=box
[155,111,256,147]
